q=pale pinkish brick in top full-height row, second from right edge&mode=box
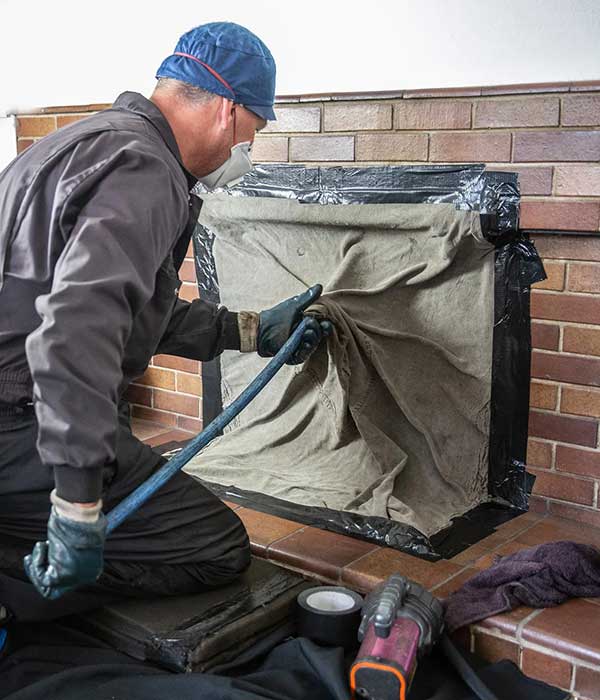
[473,97,558,129]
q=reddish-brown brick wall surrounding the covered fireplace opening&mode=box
[12,81,600,526]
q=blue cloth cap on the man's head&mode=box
[156,22,275,120]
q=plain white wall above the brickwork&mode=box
[0,0,600,116]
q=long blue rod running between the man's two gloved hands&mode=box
[106,318,308,534]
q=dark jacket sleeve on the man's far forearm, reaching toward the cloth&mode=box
[157,299,240,361]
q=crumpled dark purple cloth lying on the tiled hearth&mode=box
[445,542,600,632]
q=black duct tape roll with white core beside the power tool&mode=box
[296,586,363,649]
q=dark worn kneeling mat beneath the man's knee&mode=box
[65,558,311,672]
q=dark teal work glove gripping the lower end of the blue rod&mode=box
[24,507,106,600]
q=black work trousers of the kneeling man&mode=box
[0,411,250,621]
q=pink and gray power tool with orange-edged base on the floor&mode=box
[350,574,444,700]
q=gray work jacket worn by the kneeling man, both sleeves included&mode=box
[0,92,240,501]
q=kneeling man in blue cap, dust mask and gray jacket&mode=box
[0,23,331,636]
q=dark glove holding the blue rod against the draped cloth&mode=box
[256,284,333,365]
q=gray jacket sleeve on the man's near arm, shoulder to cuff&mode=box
[26,149,187,502]
